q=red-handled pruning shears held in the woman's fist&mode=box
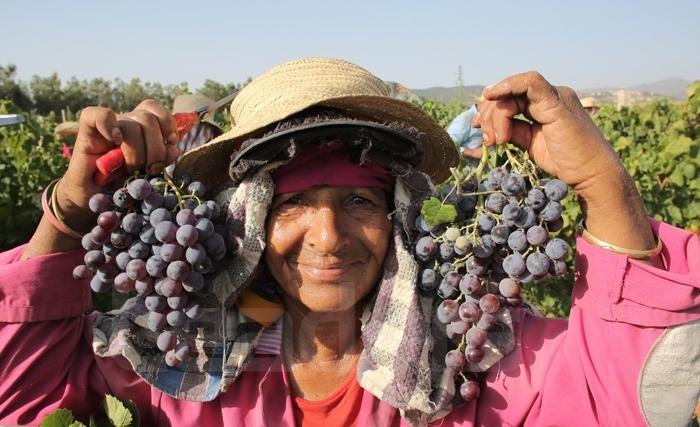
[93,91,238,186]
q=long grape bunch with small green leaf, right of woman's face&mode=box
[415,147,569,401]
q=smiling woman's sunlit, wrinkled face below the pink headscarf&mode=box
[265,187,391,312]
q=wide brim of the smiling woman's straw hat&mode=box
[175,95,459,189]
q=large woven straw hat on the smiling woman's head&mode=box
[175,58,459,188]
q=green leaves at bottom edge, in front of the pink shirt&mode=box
[40,394,140,427]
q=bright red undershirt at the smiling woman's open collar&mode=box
[293,369,363,427]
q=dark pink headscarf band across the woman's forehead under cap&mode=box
[272,145,394,194]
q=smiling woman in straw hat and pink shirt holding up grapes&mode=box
[0,58,700,426]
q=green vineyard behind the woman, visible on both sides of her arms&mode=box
[0,82,700,316]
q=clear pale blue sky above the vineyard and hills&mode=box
[0,0,700,90]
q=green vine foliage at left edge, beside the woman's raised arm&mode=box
[0,101,67,250]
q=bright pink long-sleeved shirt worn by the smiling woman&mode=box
[0,221,700,427]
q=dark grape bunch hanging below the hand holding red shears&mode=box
[73,176,235,367]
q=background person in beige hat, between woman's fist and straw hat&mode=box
[172,94,223,159]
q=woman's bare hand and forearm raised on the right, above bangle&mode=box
[472,72,655,262]
